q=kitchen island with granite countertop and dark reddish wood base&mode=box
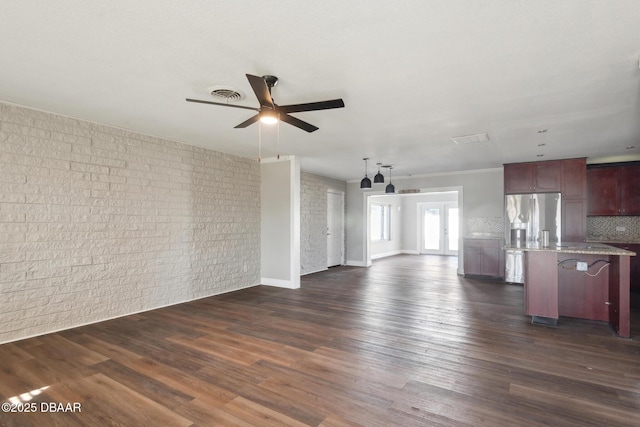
[505,243,636,338]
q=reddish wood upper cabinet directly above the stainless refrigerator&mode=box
[504,160,562,194]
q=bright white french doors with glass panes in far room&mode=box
[418,202,460,255]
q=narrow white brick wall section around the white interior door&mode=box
[300,172,346,274]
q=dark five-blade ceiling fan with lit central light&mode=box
[187,74,344,132]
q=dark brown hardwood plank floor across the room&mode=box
[0,255,640,427]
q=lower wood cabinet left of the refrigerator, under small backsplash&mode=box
[463,239,504,277]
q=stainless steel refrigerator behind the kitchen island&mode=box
[504,193,562,283]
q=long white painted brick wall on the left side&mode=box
[0,103,260,342]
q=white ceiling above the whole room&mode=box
[0,0,640,180]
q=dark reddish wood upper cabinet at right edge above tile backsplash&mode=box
[587,163,640,216]
